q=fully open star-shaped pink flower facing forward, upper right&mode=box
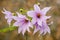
[27,4,51,26]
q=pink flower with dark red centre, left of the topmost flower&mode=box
[13,12,32,35]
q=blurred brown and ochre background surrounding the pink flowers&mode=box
[0,0,60,40]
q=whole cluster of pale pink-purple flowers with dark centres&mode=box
[2,4,51,35]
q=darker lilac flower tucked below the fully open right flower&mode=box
[33,22,50,35]
